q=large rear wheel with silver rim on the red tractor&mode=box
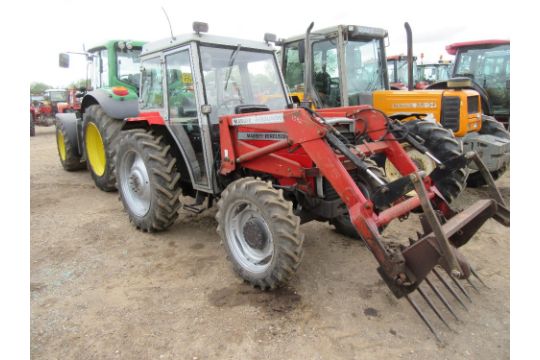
[116,129,182,232]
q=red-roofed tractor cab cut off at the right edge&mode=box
[446,40,510,125]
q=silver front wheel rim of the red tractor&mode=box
[225,200,274,273]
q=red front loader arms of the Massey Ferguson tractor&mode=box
[216,106,495,297]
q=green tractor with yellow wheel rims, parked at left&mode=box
[56,40,144,191]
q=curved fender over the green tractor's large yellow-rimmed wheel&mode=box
[81,89,139,119]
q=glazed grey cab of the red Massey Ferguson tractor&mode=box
[135,33,288,193]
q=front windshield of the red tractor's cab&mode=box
[200,46,287,124]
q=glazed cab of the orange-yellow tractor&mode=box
[282,25,389,108]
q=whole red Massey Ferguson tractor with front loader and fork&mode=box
[100,23,509,336]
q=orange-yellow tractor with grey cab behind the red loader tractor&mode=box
[278,24,510,190]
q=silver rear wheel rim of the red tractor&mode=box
[118,151,151,217]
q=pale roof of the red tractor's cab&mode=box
[141,33,274,55]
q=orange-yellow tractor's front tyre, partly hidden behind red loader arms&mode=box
[398,120,469,202]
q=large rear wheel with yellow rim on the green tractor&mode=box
[83,104,122,191]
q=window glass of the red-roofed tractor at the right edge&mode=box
[455,45,510,113]
